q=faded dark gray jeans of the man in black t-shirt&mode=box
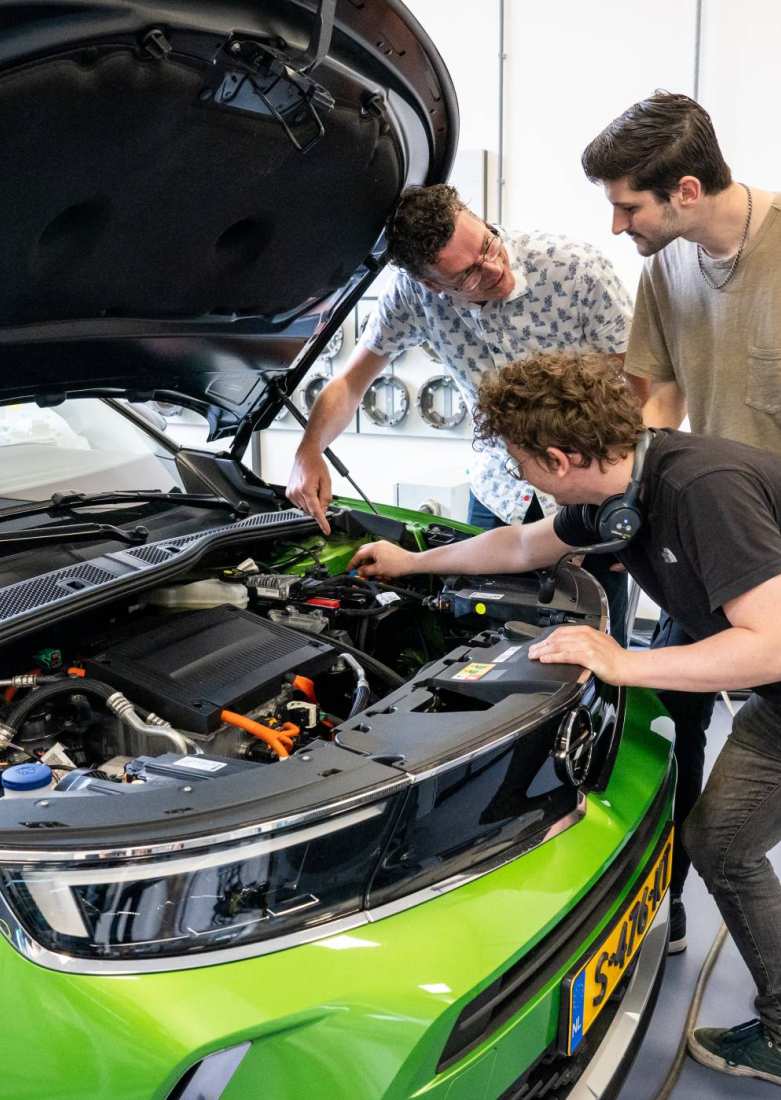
[683,695,781,1043]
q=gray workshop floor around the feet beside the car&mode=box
[619,703,781,1100]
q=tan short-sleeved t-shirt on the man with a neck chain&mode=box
[625,195,781,454]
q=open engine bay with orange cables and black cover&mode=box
[0,519,603,827]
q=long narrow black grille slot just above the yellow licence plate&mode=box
[437,774,672,1073]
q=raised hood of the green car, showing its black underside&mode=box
[0,0,458,438]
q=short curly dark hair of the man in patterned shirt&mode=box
[385,184,466,277]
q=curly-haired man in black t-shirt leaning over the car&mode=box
[351,354,781,1085]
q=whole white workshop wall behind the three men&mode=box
[262,0,781,521]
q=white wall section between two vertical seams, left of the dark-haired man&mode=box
[504,0,696,295]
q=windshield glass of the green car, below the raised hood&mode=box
[0,397,184,507]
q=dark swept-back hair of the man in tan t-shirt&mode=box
[581,91,733,202]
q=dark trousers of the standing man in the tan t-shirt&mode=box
[651,612,716,897]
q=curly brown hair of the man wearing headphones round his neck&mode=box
[475,351,644,469]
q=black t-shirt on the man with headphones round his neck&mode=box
[553,430,781,702]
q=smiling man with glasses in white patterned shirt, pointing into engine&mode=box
[287,184,631,644]
